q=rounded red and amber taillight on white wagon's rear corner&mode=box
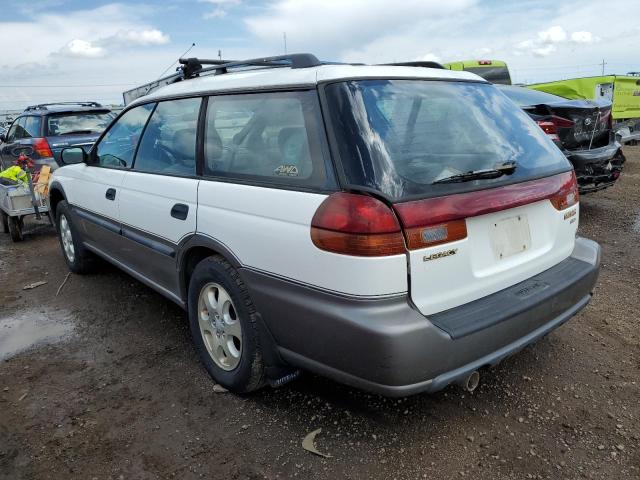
[311,192,405,257]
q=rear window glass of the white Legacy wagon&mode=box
[326,80,571,201]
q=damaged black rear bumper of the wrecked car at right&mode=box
[563,142,625,193]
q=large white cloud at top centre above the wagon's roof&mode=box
[245,0,477,61]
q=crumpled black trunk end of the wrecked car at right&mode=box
[523,100,613,150]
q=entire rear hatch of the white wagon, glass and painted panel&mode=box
[325,80,578,315]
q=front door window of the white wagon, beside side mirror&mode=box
[95,104,155,168]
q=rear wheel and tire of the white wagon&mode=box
[188,255,265,393]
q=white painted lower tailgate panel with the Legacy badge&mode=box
[409,200,579,315]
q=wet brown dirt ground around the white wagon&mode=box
[0,147,640,480]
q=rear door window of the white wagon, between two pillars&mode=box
[133,98,202,175]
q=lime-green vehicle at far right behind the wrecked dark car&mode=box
[527,75,640,143]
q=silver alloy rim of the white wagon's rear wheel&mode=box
[198,283,242,371]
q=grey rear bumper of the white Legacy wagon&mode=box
[241,238,600,396]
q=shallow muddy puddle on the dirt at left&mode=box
[0,310,73,360]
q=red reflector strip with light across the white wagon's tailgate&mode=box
[394,171,578,249]
